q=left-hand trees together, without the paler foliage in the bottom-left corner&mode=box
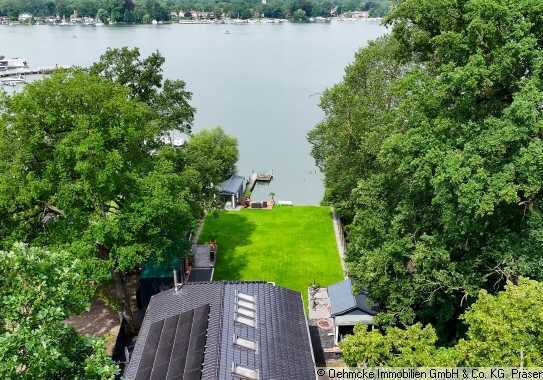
[0,48,238,332]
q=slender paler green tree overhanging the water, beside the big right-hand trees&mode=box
[308,38,404,223]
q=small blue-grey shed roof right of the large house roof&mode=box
[328,279,378,317]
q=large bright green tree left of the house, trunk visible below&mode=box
[0,71,203,330]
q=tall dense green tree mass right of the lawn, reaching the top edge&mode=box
[309,0,543,341]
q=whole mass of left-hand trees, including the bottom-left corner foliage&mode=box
[0,48,238,379]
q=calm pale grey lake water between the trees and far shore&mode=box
[0,21,386,204]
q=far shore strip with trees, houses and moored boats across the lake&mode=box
[0,0,389,26]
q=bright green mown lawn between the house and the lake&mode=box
[200,206,343,304]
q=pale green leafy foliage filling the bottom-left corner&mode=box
[0,244,117,379]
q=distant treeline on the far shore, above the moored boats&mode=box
[0,0,389,24]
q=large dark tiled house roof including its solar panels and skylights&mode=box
[125,282,315,380]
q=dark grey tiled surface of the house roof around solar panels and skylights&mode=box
[125,282,315,380]
